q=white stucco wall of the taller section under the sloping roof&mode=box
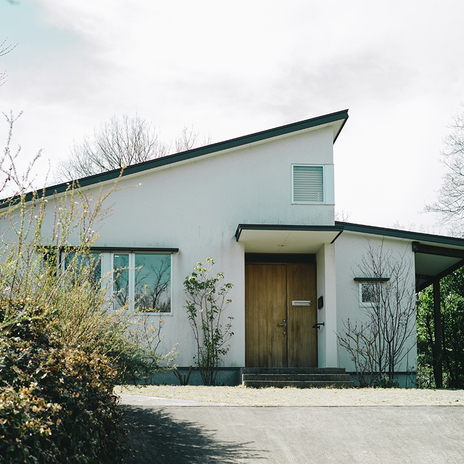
[0,127,334,366]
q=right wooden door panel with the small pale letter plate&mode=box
[287,263,317,367]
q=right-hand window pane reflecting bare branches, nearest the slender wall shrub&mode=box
[135,253,171,313]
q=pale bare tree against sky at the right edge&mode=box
[426,107,464,233]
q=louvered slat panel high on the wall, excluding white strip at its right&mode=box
[293,166,324,203]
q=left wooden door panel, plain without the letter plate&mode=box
[245,264,287,367]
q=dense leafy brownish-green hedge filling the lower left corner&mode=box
[0,301,124,463]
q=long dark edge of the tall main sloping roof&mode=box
[0,109,348,209]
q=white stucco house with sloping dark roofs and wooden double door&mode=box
[6,111,464,383]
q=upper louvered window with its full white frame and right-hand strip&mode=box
[292,164,334,204]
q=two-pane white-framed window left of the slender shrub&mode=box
[113,253,171,313]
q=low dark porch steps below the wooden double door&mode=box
[241,367,354,388]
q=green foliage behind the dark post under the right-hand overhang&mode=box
[417,268,464,388]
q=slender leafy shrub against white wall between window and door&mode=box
[184,258,234,385]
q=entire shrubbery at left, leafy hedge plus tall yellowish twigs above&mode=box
[0,116,176,463]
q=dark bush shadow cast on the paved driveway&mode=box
[119,405,266,464]
